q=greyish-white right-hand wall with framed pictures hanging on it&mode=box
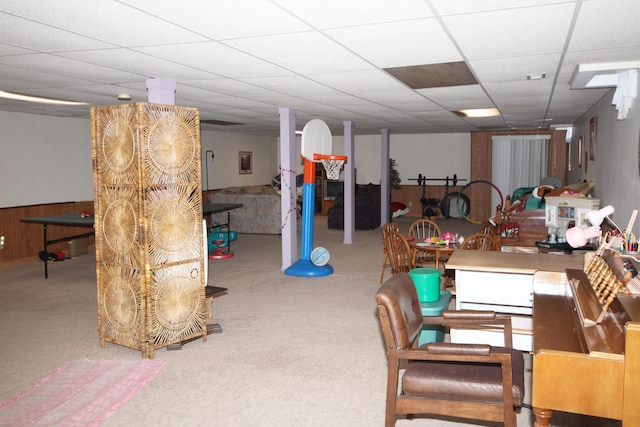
[568,85,640,236]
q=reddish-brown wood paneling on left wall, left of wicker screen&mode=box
[0,200,94,266]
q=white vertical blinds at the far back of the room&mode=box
[491,135,551,208]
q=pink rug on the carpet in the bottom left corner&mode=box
[0,359,165,427]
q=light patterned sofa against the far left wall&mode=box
[207,185,282,234]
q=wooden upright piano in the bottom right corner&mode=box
[532,251,640,427]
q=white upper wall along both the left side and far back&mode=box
[0,111,470,207]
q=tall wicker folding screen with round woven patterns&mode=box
[91,103,207,358]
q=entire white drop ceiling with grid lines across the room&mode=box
[0,0,640,135]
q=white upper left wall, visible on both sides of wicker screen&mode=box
[0,111,279,208]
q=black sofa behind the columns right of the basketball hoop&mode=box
[327,184,386,230]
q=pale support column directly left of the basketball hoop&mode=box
[278,107,298,271]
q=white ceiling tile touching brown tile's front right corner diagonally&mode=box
[442,3,575,60]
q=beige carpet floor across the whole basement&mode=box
[0,217,620,427]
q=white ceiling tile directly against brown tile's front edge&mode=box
[325,18,461,68]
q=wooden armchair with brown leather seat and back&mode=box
[376,273,525,427]
